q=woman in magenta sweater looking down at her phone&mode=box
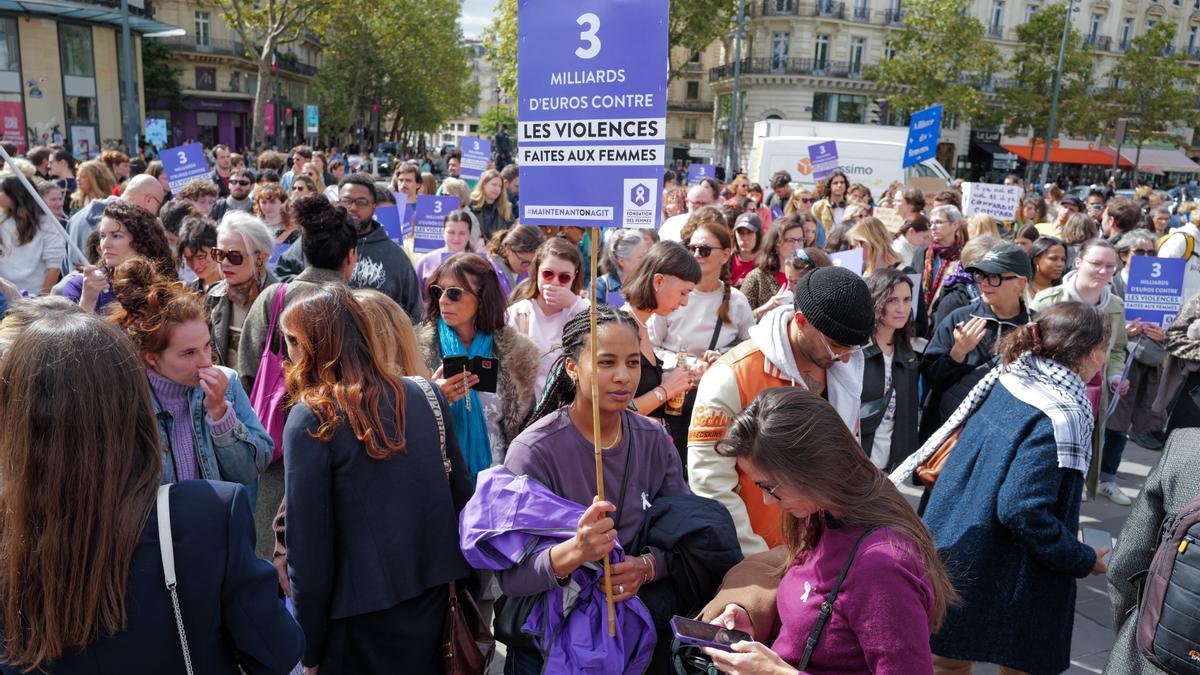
[704,388,955,675]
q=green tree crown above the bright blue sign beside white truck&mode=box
[876,0,1001,123]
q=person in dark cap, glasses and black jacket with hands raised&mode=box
[919,239,1033,441]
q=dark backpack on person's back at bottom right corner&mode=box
[1138,485,1200,675]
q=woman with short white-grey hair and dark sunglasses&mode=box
[204,211,277,369]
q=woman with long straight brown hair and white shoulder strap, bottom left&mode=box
[0,313,304,675]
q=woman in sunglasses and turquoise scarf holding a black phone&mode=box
[416,253,538,478]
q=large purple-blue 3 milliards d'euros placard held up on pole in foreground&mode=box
[517,0,670,228]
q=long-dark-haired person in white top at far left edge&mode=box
[0,175,66,295]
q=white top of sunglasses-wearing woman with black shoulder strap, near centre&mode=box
[646,282,755,358]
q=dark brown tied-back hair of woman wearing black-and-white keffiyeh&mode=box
[996,300,1111,370]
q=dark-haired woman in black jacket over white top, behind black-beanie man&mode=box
[859,269,920,471]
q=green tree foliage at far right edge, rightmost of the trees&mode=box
[1108,22,1200,169]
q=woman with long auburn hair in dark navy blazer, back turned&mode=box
[280,285,472,675]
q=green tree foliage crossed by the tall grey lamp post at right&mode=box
[1000,5,1099,176]
